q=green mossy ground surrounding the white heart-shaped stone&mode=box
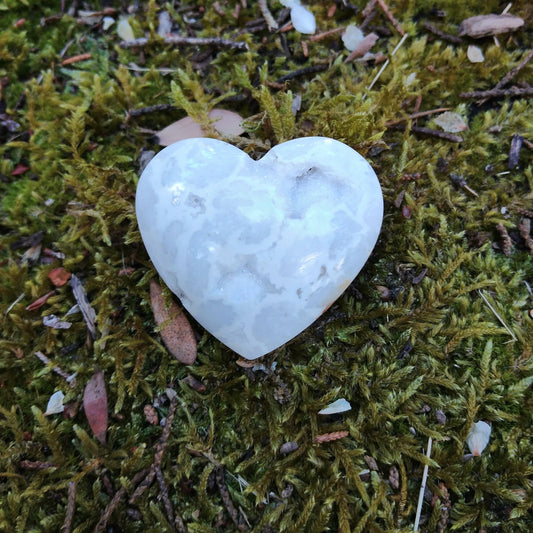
[0,0,533,533]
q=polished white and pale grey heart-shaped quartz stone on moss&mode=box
[136,137,383,359]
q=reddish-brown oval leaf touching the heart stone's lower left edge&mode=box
[150,280,196,365]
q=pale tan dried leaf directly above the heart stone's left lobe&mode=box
[157,109,244,146]
